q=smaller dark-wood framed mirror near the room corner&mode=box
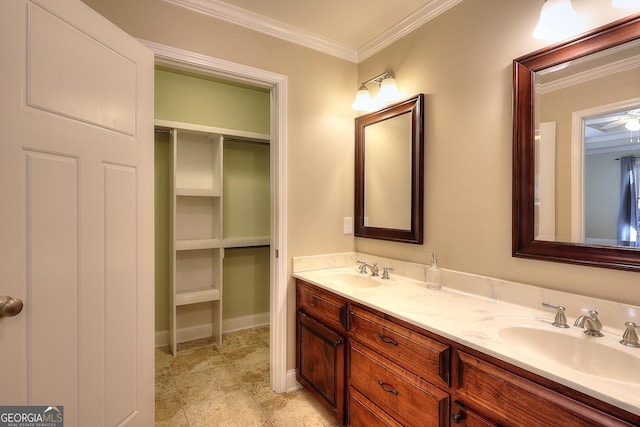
[354,94,424,244]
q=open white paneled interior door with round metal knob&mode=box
[0,0,154,427]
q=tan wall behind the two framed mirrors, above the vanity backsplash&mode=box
[356,0,640,305]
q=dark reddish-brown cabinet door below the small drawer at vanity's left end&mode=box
[296,311,345,423]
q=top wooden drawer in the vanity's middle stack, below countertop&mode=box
[350,307,450,386]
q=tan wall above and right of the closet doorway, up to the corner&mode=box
[83,0,358,369]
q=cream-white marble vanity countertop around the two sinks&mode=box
[293,260,640,415]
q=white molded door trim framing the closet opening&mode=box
[138,39,288,393]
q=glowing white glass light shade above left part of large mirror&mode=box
[533,0,582,40]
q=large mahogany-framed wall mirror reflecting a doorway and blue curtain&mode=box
[513,15,640,271]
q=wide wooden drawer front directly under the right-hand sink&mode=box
[456,352,632,427]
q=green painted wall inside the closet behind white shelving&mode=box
[155,67,270,332]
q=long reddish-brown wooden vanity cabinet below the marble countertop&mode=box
[296,279,640,427]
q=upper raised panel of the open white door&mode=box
[27,4,136,135]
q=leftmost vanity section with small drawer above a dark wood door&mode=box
[296,280,348,423]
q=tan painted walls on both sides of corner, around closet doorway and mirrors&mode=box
[85,0,640,368]
